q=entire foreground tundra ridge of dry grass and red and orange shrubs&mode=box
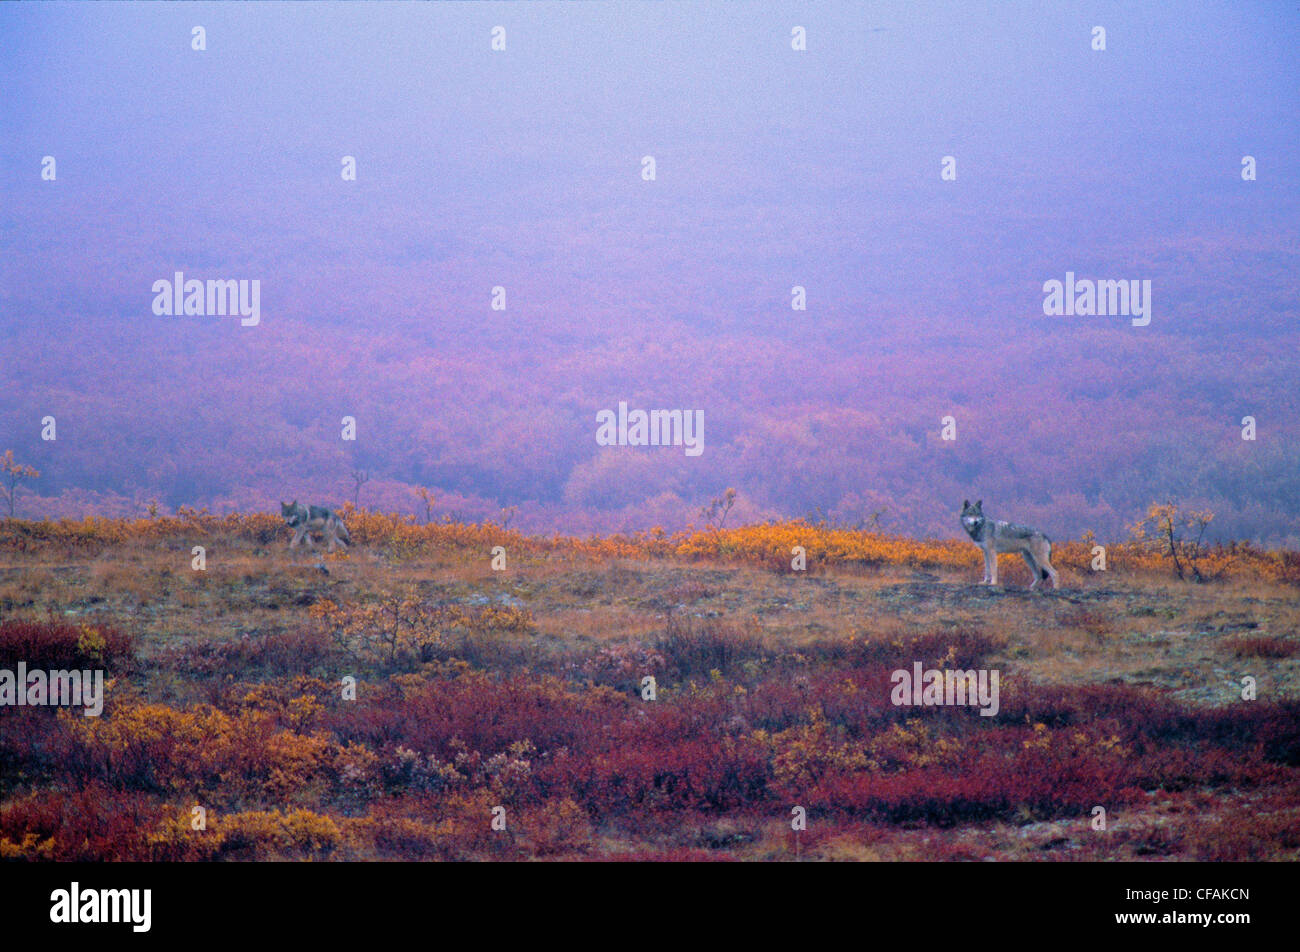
[0,512,1300,861]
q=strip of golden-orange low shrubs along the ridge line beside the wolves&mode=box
[0,505,1300,584]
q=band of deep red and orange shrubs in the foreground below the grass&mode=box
[0,616,1300,860]
